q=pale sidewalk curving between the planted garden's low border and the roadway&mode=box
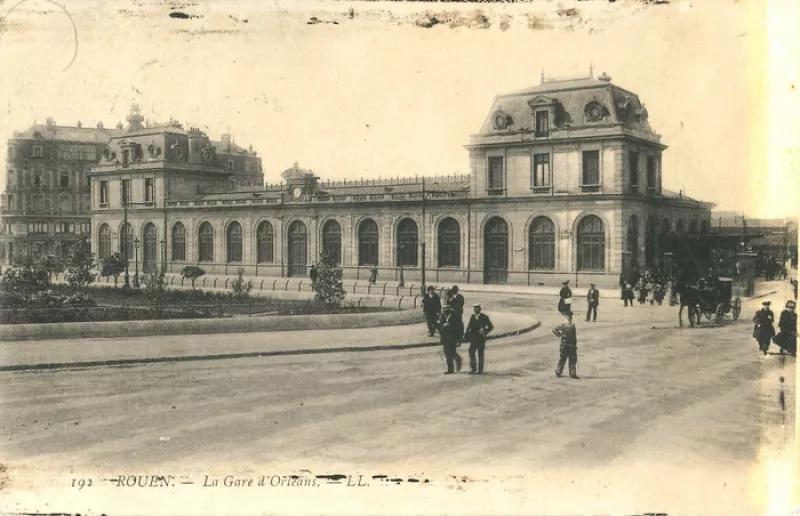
[0,312,539,371]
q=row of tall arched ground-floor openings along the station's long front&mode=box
[98,215,608,270]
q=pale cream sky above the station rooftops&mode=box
[0,0,800,217]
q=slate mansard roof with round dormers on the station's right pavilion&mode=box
[479,75,658,138]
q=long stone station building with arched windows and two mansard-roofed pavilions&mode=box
[90,75,712,286]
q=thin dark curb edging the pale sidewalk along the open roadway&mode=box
[0,321,541,372]
